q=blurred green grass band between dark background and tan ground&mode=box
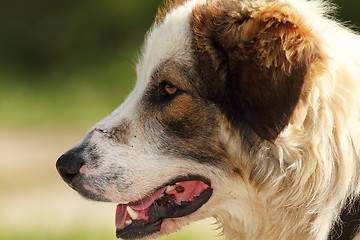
[0,49,135,127]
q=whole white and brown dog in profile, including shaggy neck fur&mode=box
[56,0,360,240]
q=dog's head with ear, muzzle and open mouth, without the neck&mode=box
[57,0,320,239]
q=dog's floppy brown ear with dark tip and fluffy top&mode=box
[192,1,318,141]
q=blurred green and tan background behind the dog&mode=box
[0,0,360,240]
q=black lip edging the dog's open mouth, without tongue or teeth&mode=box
[116,175,213,240]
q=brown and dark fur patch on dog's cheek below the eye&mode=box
[159,106,226,164]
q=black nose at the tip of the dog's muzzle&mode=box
[56,148,83,185]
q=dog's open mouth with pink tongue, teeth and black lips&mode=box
[115,176,213,239]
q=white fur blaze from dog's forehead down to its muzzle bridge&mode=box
[96,0,206,128]
